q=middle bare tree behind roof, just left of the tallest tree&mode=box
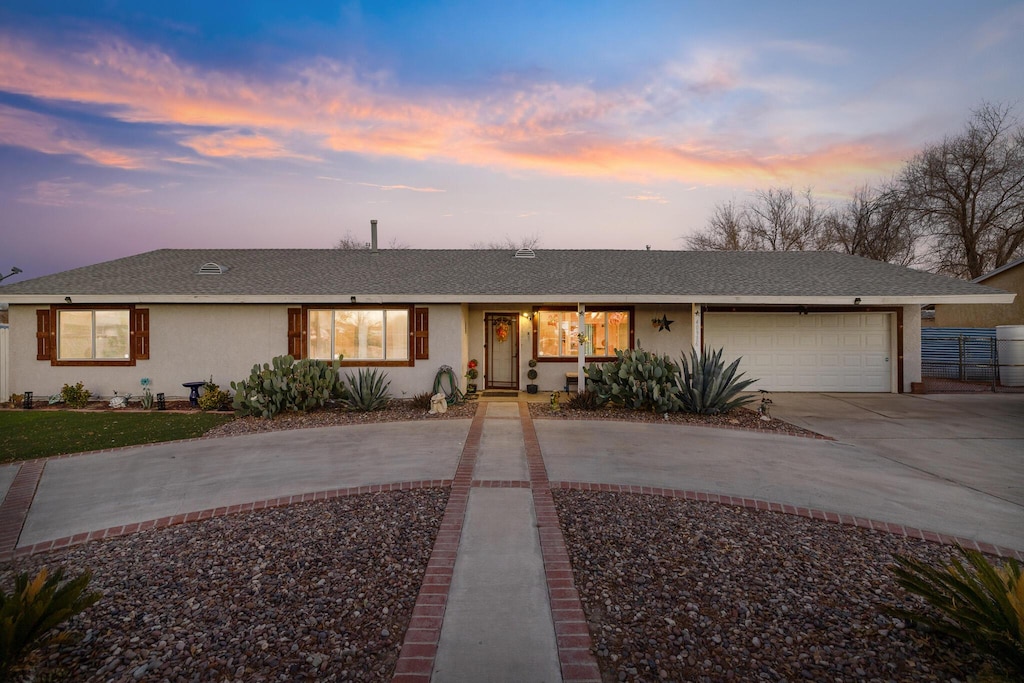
[824,183,918,266]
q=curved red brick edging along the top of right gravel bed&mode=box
[550,481,1024,561]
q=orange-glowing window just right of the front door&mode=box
[535,309,633,360]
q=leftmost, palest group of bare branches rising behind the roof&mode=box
[686,187,827,251]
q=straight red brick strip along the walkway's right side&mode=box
[516,402,601,683]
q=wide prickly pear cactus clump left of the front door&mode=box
[231,355,345,418]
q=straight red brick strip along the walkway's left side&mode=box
[391,402,487,683]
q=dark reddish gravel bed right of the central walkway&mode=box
[554,490,1003,682]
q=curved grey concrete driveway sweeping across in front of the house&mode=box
[6,393,1024,550]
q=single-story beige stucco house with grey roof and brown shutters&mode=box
[0,249,1014,397]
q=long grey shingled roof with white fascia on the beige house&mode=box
[0,249,1011,303]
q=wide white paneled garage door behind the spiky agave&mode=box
[703,313,892,391]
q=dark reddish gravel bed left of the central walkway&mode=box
[0,488,447,683]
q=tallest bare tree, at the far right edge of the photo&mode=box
[901,103,1024,279]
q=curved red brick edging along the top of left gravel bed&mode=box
[7,481,452,561]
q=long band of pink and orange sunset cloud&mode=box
[0,34,902,188]
